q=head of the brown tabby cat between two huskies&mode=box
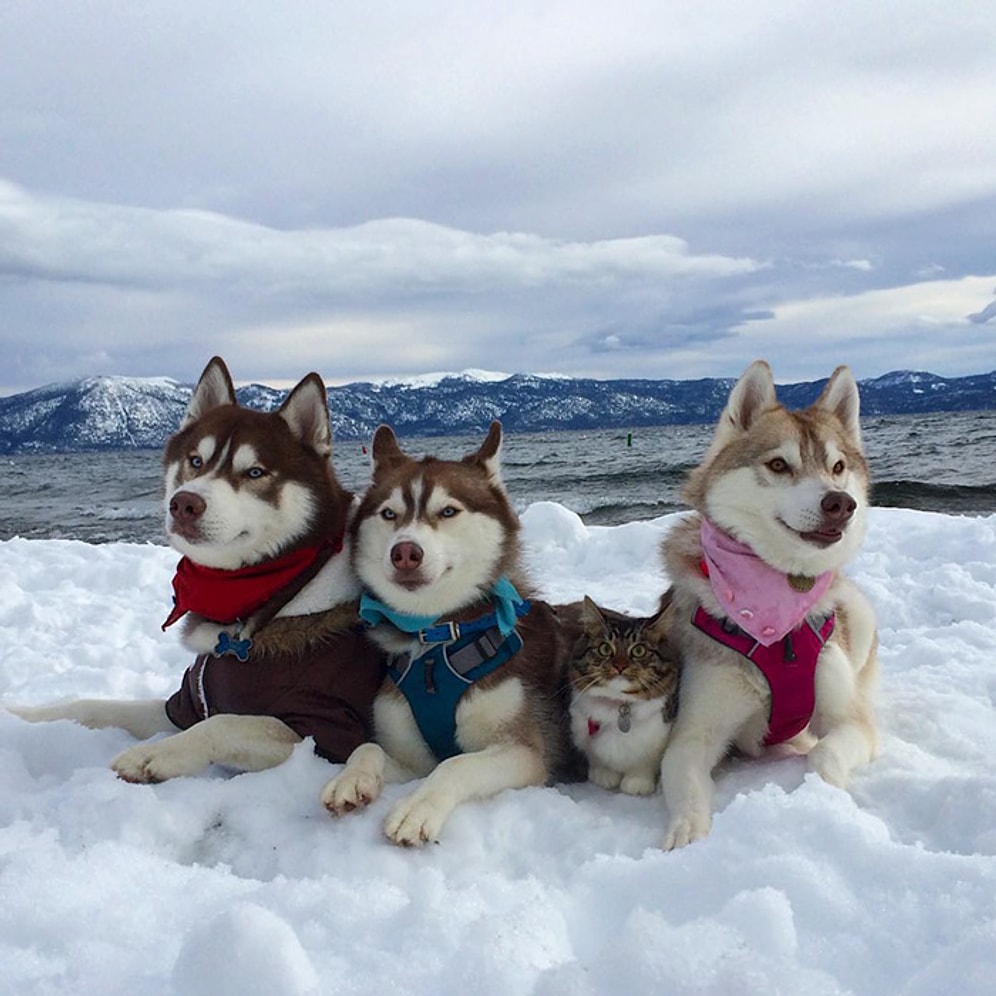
[569,595,679,699]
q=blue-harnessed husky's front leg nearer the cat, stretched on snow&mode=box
[384,743,547,847]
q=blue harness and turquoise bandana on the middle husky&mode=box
[360,578,531,761]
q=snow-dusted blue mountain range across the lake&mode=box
[0,370,996,454]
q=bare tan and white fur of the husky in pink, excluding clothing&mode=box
[661,361,877,849]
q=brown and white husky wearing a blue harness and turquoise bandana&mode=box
[321,422,570,847]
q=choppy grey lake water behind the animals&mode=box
[0,411,996,543]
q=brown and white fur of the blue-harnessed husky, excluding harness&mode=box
[321,422,570,846]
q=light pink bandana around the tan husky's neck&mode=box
[700,519,833,647]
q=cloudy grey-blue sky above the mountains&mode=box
[0,0,996,394]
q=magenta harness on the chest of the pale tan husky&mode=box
[692,606,836,746]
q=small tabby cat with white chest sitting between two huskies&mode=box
[568,595,680,795]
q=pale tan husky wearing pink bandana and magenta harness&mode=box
[661,361,877,849]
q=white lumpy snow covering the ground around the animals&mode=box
[0,503,996,996]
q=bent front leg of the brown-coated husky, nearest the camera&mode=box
[111,713,301,784]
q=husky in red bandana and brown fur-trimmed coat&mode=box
[11,357,383,782]
